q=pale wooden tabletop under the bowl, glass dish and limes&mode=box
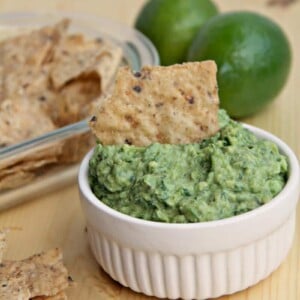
[0,0,300,300]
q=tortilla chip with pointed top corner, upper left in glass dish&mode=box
[0,19,69,110]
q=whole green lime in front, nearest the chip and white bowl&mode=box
[187,12,291,118]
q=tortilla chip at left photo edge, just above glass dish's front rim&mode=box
[0,98,56,147]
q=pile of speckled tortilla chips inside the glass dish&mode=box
[0,19,123,190]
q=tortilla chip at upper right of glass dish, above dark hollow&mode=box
[51,35,122,89]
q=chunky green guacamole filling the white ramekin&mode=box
[89,111,288,223]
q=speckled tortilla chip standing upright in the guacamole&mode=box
[90,61,219,146]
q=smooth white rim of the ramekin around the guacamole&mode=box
[78,124,300,230]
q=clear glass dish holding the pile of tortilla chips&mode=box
[0,13,159,209]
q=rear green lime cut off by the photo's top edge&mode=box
[135,0,218,65]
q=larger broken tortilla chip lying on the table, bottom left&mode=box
[0,249,69,300]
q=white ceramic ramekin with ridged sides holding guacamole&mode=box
[79,125,300,299]
